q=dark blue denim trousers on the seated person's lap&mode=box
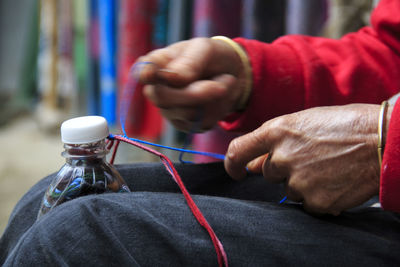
[0,163,400,266]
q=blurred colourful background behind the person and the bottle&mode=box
[0,0,376,234]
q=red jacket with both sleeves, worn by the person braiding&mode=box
[220,0,400,212]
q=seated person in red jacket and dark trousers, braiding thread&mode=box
[0,0,400,266]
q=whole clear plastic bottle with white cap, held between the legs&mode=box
[38,116,130,219]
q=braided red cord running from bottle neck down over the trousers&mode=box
[109,135,228,266]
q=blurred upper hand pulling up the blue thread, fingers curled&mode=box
[138,38,245,131]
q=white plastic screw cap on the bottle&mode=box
[61,116,109,144]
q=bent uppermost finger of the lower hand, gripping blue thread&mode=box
[224,123,274,180]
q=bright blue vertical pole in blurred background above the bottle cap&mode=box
[98,0,117,125]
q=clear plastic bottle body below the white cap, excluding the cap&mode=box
[38,140,130,219]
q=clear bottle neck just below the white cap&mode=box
[61,140,108,164]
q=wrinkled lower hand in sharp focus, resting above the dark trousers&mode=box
[225,104,390,215]
